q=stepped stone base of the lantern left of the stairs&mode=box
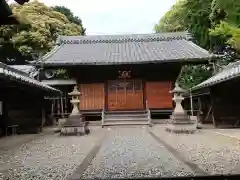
[60,114,90,136]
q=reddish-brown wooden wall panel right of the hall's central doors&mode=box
[145,81,173,109]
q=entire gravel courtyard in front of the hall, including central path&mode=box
[0,126,240,180]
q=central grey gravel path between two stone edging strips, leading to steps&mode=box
[82,128,194,179]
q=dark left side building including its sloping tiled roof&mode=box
[0,63,61,136]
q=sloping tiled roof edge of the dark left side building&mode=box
[0,63,61,93]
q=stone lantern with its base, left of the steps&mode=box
[61,86,90,135]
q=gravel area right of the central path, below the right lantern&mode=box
[152,126,240,174]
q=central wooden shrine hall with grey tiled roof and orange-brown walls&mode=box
[35,32,214,125]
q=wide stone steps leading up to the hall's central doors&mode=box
[102,110,151,127]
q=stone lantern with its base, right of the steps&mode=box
[166,83,196,133]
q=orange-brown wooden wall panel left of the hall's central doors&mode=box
[79,83,105,110]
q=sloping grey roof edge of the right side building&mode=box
[191,61,240,90]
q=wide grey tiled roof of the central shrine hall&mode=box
[38,32,214,66]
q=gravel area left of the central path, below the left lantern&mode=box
[0,126,105,180]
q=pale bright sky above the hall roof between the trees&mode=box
[12,0,176,35]
